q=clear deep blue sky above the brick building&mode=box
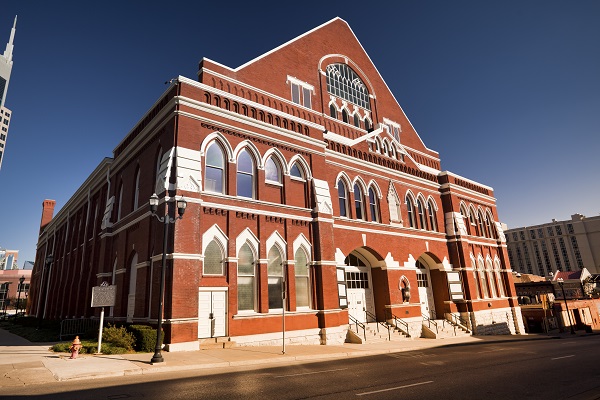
[0,0,600,266]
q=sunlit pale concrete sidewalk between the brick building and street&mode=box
[0,329,570,387]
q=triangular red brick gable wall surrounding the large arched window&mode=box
[202,17,438,157]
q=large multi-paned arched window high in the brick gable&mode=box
[327,64,371,110]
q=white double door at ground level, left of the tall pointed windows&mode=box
[198,291,227,338]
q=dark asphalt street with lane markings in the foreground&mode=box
[0,336,600,400]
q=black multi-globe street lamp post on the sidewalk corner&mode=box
[148,193,187,364]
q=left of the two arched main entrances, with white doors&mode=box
[344,250,375,322]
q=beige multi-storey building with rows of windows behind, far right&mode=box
[506,214,600,276]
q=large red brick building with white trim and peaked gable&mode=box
[29,18,523,350]
